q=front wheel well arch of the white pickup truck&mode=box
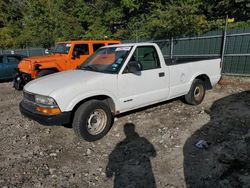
[72,95,115,118]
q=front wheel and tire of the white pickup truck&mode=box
[72,100,112,141]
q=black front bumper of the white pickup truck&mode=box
[19,101,71,126]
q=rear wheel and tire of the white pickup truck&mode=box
[184,79,206,105]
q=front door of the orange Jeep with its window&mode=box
[70,44,90,69]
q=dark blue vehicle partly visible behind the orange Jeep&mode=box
[0,54,26,82]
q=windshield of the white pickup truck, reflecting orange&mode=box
[79,46,131,73]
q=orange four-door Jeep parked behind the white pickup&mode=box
[13,40,121,90]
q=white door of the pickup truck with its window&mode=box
[118,46,169,110]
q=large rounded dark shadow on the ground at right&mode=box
[183,91,250,188]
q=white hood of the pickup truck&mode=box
[24,70,117,97]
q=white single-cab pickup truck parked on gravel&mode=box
[20,43,221,141]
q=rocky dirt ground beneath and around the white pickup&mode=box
[0,77,250,188]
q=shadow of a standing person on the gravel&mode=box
[106,123,156,188]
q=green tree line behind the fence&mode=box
[0,0,250,48]
